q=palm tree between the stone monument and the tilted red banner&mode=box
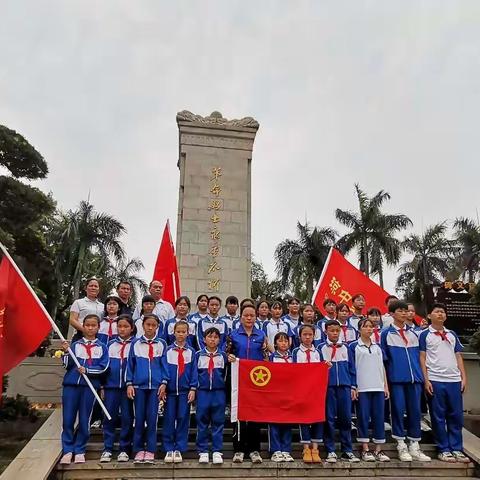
[275,222,337,300]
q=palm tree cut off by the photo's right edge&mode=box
[453,218,480,283]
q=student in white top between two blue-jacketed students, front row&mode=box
[349,318,390,462]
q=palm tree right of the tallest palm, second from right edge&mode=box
[397,222,456,309]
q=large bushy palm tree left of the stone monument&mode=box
[57,201,126,299]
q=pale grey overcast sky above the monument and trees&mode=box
[0,0,480,289]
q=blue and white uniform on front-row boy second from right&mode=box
[380,324,423,441]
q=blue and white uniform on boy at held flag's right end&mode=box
[318,338,356,453]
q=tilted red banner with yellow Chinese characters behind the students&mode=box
[312,248,389,314]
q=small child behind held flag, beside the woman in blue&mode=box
[268,332,295,462]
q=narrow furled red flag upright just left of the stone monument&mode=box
[153,220,180,306]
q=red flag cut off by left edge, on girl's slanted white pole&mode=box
[0,251,52,377]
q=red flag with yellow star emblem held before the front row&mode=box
[231,360,328,423]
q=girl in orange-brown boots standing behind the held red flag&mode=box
[292,325,323,463]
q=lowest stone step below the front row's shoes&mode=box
[53,460,475,480]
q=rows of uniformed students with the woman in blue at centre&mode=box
[60,284,469,464]
